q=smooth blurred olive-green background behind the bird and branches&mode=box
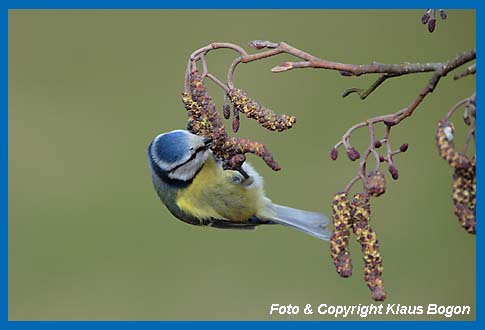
[9,10,476,320]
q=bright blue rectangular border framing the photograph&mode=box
[0,0,485,330]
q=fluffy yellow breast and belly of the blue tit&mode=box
[177,156,264,222]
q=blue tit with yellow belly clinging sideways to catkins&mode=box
[148,130,331,240]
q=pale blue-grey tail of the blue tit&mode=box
[262,203,332,241]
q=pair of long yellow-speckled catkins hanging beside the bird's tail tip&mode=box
[330,191,386,301]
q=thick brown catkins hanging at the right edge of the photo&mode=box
[436,119,476,234]
